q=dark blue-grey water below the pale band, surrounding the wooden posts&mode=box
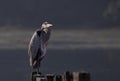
[0,48,120,81]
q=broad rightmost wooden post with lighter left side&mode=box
[73,72,90,81]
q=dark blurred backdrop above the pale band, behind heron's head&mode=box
[0,0,120,28]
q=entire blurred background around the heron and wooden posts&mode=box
[0,0,120,81]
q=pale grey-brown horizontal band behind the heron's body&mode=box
[0,29,120,50]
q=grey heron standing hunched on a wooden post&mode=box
[28,22,53,72]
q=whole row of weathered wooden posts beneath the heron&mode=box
[32,71,90,81]
